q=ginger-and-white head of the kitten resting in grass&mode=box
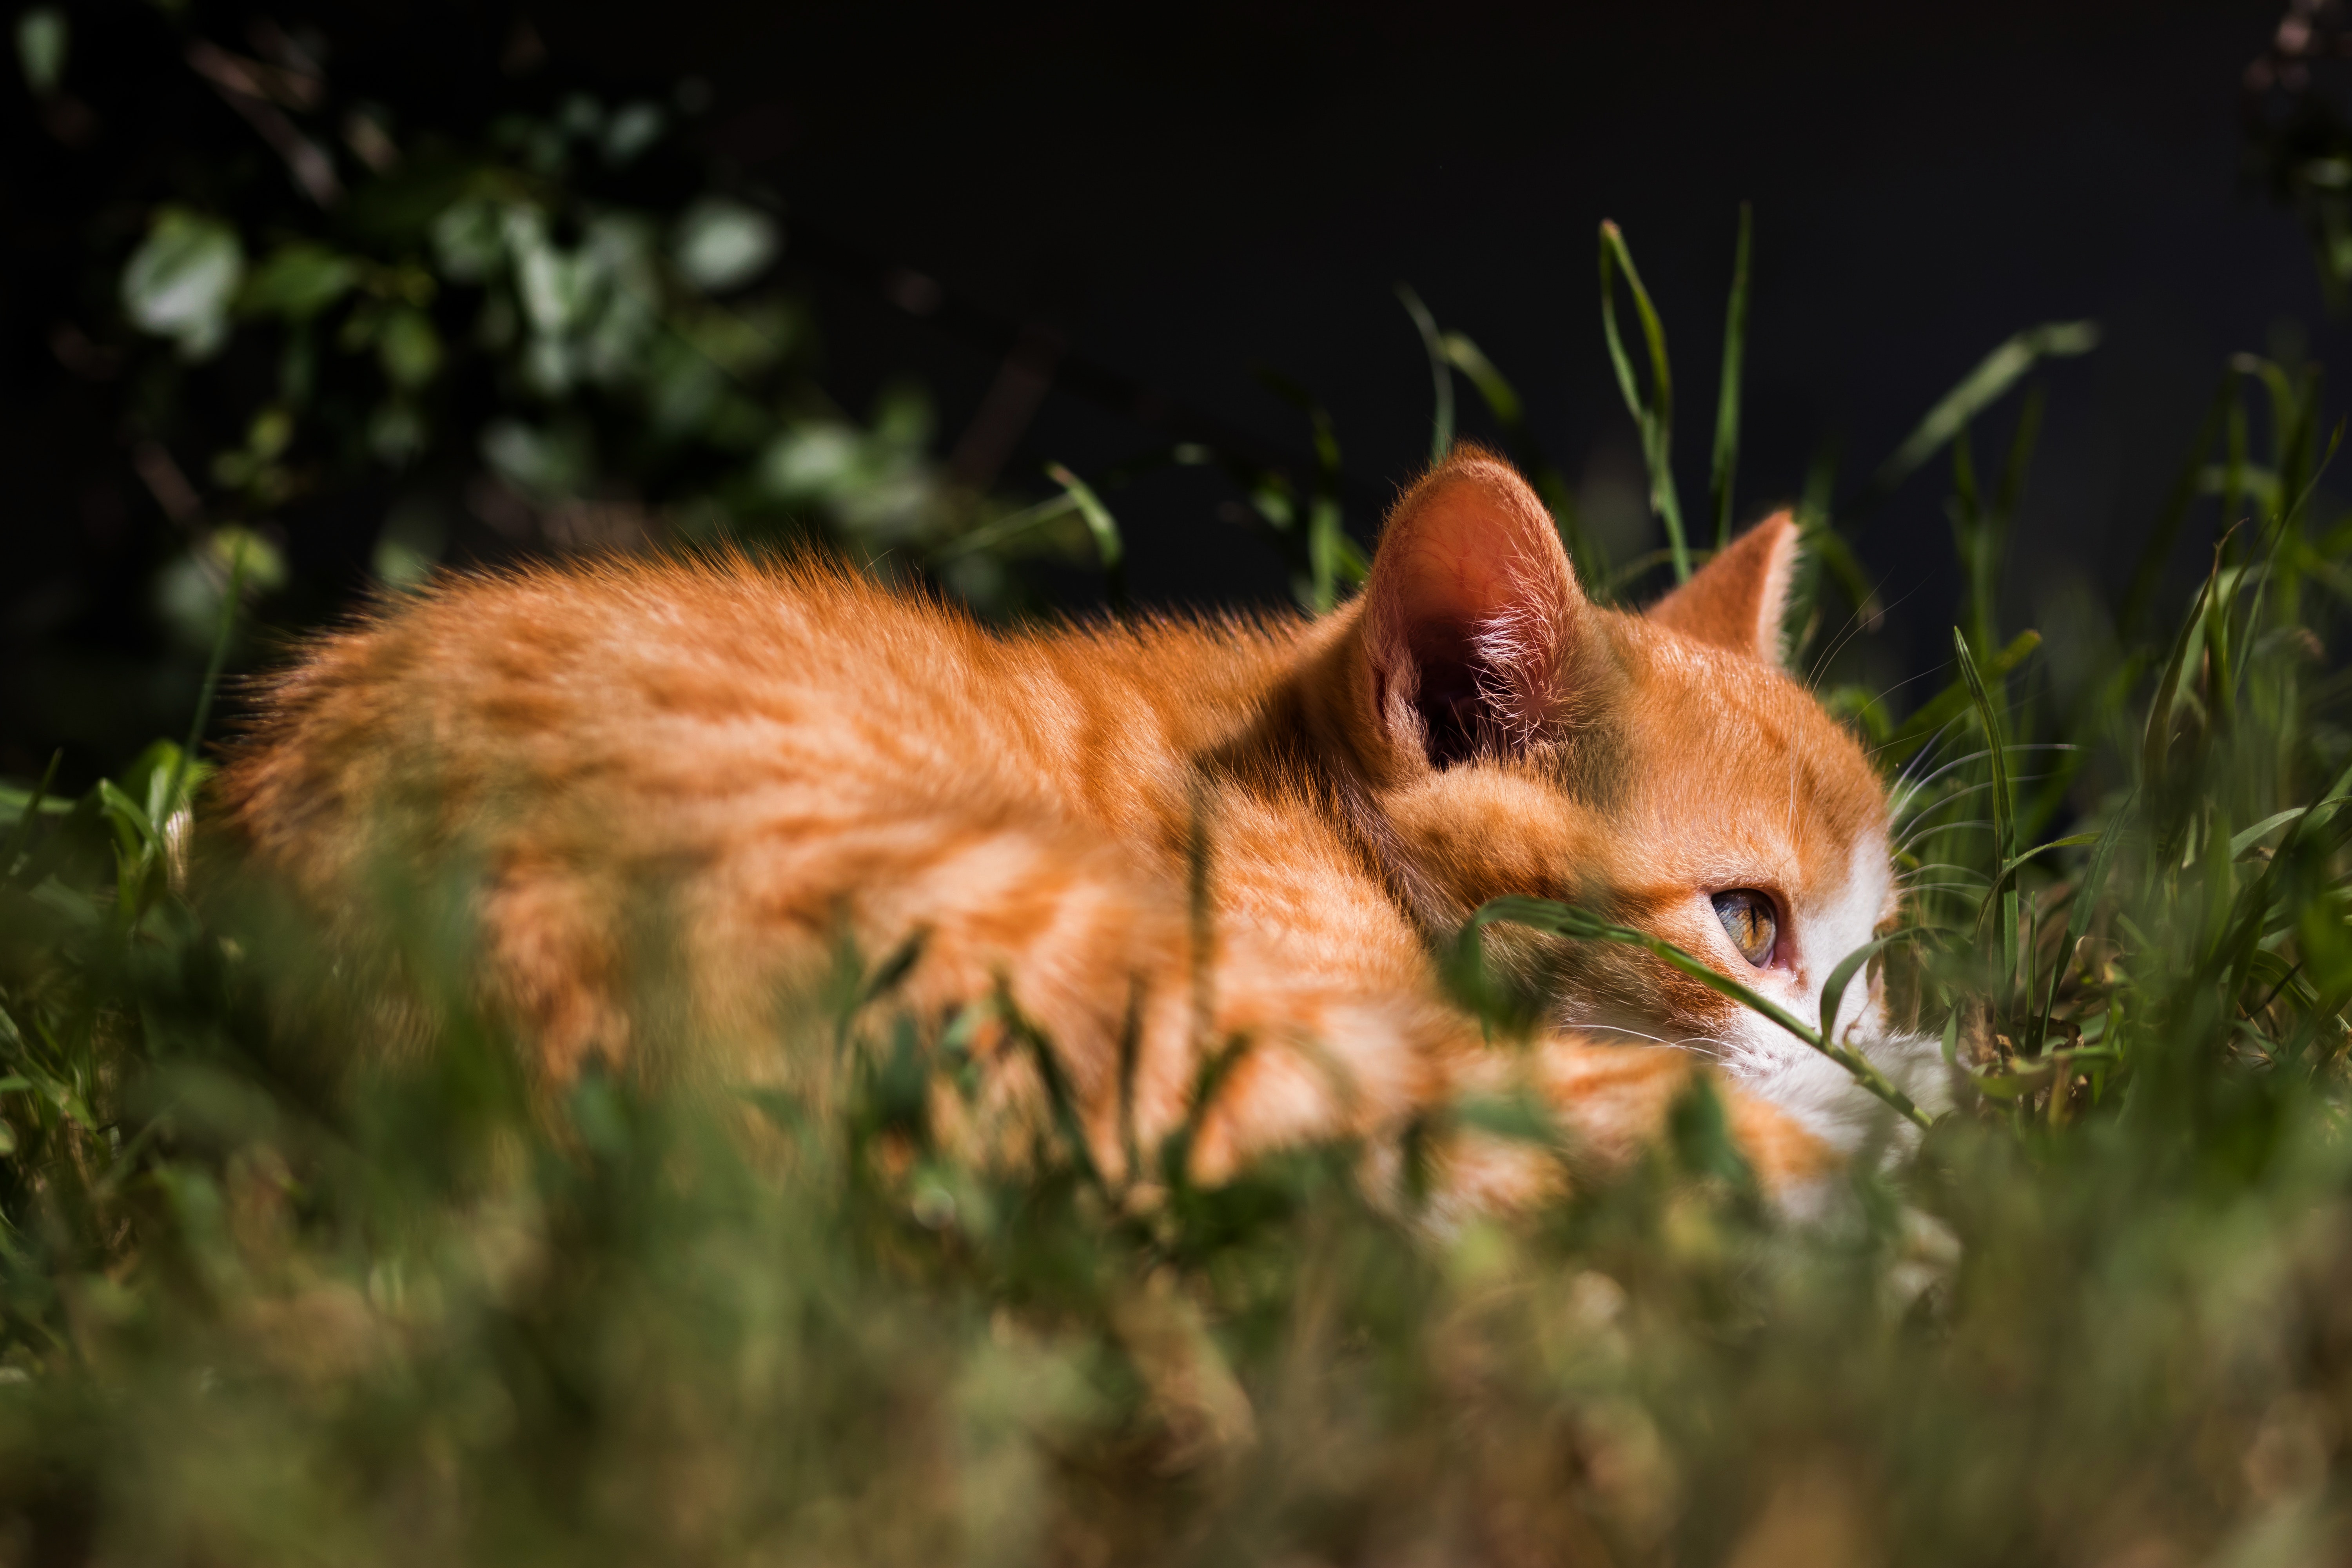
[1324,449,1896,1114]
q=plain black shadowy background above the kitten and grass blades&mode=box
[0,0,2340,771]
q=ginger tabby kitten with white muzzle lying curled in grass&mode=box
[219,449,1896,1206]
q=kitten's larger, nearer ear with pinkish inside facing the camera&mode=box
[1364,446,1590,766]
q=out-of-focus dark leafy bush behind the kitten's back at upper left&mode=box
[9,0,1124,766]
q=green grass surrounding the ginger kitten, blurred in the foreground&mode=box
[0,211,2352,1563]
